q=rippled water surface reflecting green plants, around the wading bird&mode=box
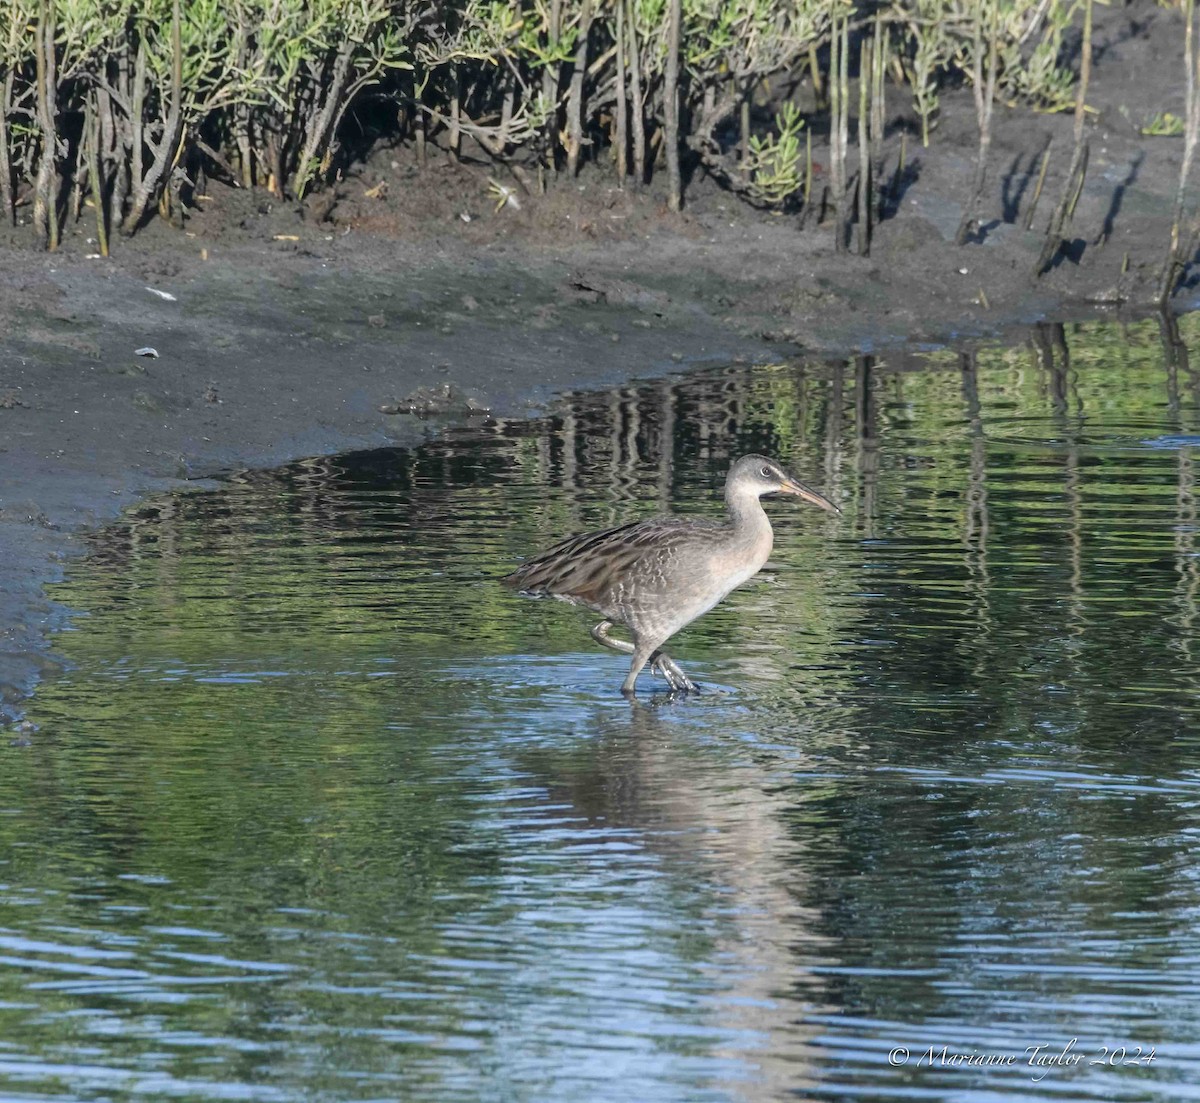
[0,317,1200,1103]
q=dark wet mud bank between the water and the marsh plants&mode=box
[0,5,1198,719]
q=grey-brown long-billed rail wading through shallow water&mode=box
[504,456,840,695]
